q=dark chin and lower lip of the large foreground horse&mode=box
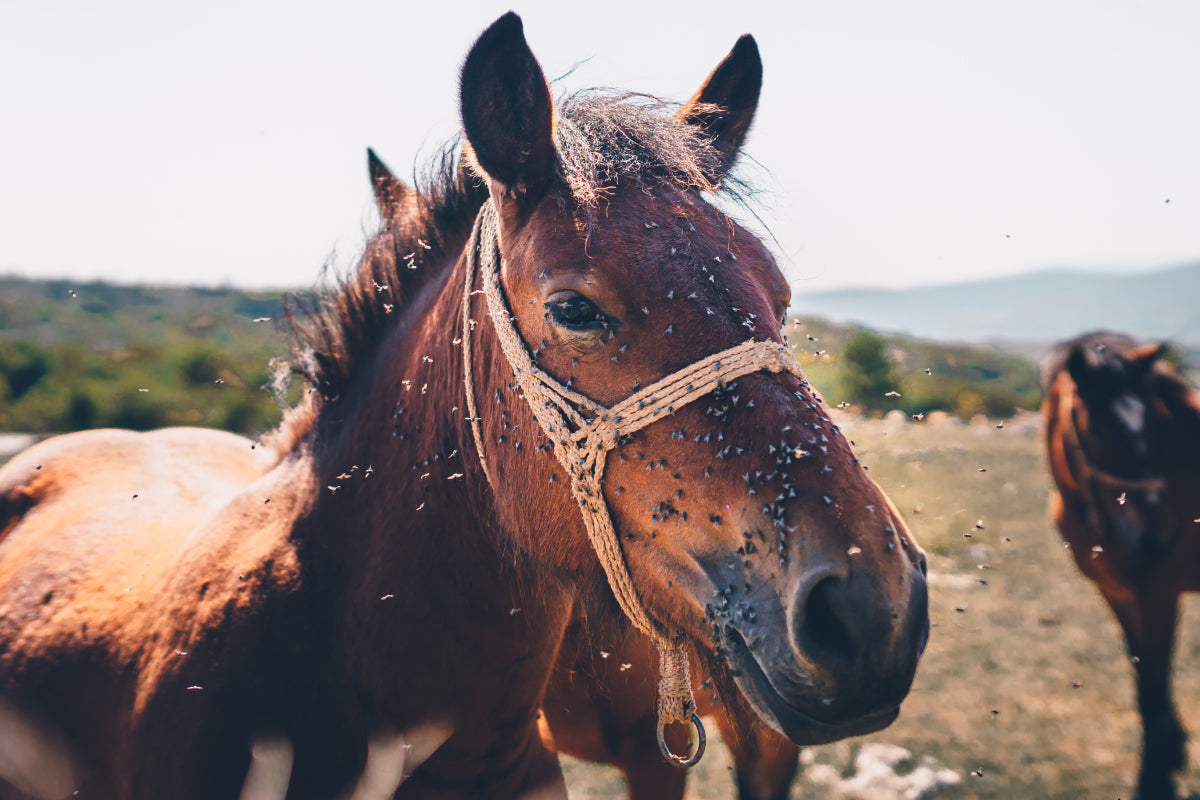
[725,628,900,745]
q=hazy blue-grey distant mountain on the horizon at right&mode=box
[792,261,1200,345]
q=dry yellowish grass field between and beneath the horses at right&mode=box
[566,415,1200,800]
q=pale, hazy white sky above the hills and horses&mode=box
[0,0,1200,293]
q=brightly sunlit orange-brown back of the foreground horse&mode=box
[0,428,271,671]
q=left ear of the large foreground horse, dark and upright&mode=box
[460,11,557,201]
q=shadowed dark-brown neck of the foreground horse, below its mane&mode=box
[295,251,570,722]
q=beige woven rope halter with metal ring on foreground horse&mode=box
[462,200,804,766]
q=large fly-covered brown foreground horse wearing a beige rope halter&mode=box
[0,13,929,800]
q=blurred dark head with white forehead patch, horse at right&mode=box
[1066,333,1166,558]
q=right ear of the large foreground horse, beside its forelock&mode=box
[679,34,762,182]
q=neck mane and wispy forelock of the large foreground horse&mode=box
[281,90,748,419]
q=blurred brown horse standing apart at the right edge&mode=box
[1042,332,1200,800]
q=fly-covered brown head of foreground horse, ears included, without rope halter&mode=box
[462,14,929,742]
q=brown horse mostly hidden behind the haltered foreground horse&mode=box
[367,148,800,800]
